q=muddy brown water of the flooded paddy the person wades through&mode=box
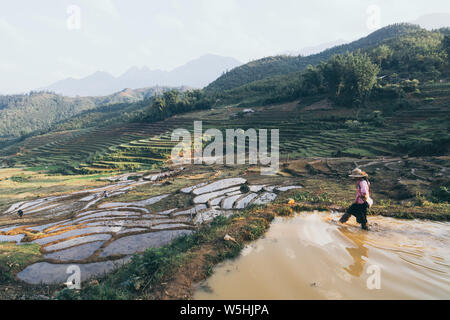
[194,212,450,299]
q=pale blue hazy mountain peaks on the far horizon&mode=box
[44,54,242,96]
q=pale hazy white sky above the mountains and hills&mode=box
[0,0,450,94]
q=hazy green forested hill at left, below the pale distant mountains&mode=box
[0,87,176,143]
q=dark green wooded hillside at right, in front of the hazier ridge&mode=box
[208,24,450,107]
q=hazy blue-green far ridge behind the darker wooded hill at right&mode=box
[205,23,422,92]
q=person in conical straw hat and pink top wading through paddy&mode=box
[339,169,373,230]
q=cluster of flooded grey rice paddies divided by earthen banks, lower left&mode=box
[0,169,301,284]
